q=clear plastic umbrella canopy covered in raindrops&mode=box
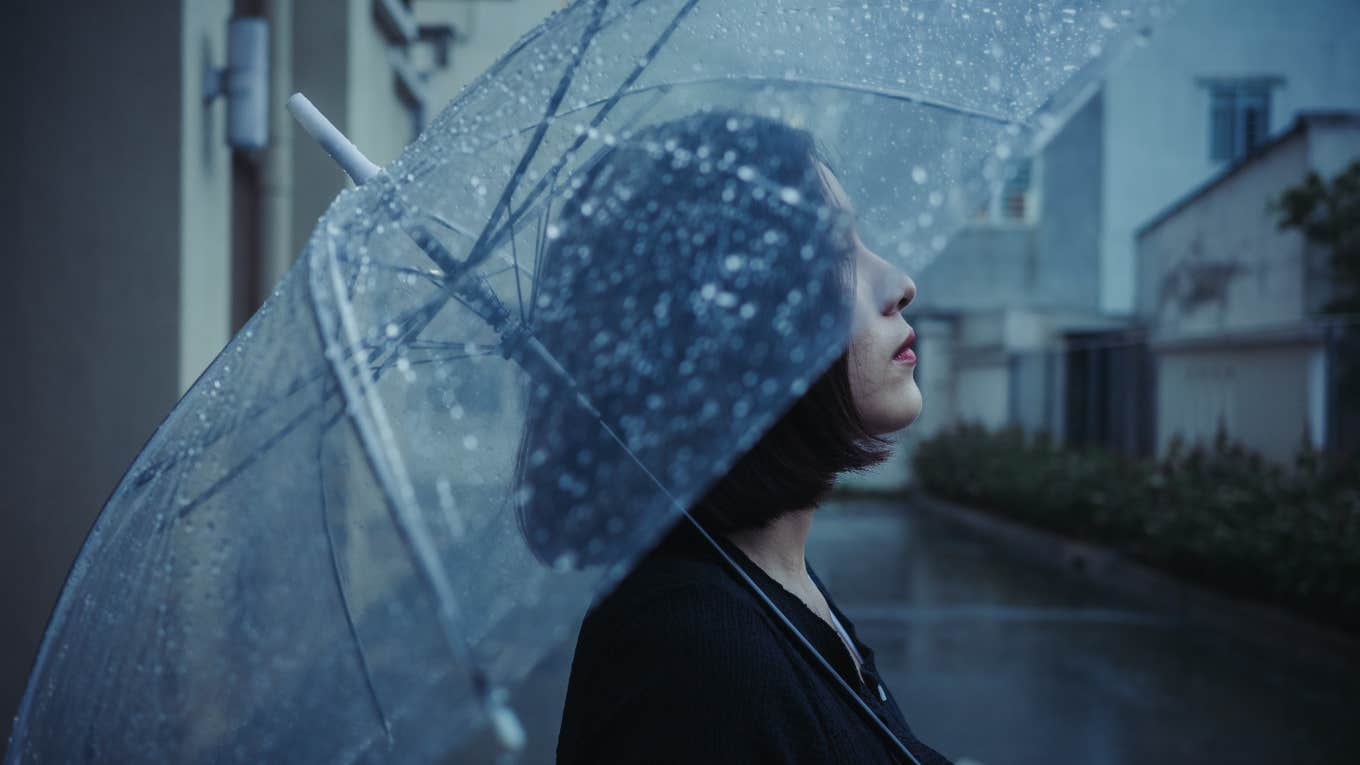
[7,0,1167,762]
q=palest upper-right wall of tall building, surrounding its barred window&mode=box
[1100,0,1360,312]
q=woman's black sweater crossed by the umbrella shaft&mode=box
[558,520,948,765]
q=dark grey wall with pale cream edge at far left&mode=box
[0,1,228,728]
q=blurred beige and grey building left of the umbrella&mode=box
[0,0,564,731]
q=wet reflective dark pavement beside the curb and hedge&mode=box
[458,501,1360,765]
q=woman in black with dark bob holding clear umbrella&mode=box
[520,113,945,765]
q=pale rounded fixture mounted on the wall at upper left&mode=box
[203,16,269,151]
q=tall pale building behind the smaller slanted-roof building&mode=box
[862,0,1360,487]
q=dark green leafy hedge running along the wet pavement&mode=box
[914,425,1360,633]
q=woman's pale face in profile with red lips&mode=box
[820,166,922,436]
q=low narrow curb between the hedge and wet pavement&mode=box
[898,491,1360,670]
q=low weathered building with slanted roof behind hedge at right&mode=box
[1136,112,1360,461]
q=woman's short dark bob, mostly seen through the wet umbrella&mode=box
[515,112,888,564]
